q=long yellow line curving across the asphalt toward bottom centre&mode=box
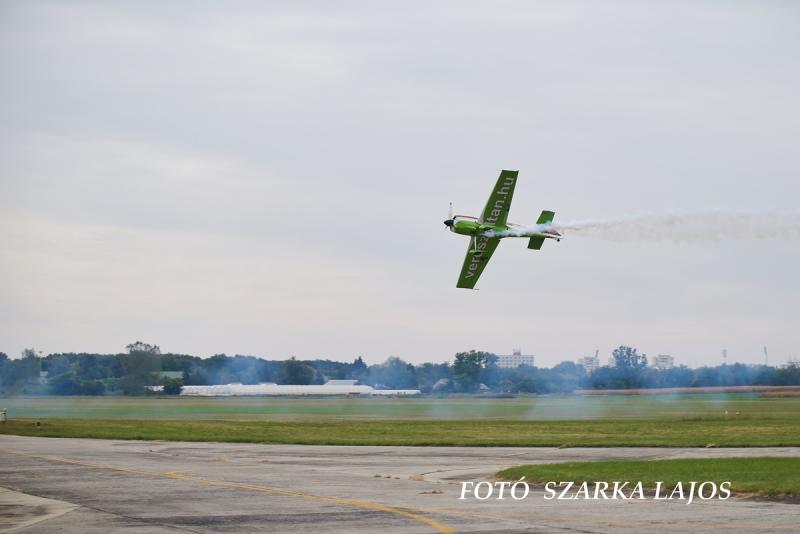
[3,449,455,534]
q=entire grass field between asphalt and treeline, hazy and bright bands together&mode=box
[0,395,800,447]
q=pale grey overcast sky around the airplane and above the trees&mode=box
[0,1,800,366]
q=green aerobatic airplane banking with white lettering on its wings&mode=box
[444,170,563,289]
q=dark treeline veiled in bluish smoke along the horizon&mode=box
[0,342,800,395]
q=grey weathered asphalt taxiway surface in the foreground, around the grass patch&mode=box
[0,436,800,533]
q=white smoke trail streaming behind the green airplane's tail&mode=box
[515,209,800,242]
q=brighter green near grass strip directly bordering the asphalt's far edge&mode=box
[0,417,800,447]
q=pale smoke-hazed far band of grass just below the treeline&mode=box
[0,394,800,425]
